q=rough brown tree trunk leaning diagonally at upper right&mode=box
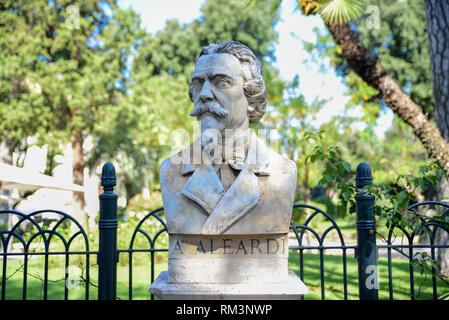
[327,22,449,172]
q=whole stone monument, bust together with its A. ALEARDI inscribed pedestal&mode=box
[151,41,307,299]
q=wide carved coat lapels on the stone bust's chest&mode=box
[181,131,270,234]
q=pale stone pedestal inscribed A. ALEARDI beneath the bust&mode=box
[150,234,308,300]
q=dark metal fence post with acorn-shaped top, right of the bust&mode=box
[355,162,379,300]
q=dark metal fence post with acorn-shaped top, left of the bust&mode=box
[98,162,118,300]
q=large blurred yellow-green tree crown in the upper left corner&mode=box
[0,0,139,175]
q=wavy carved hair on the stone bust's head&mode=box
[189,41,267,122]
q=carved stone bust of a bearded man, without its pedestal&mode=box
[160,41,296,235]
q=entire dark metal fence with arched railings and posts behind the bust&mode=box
[0,163,449,300]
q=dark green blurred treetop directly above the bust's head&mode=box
[144,0,279,77]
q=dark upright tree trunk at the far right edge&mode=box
[425,0,449,276]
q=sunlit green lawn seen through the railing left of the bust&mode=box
[0,253,167,300]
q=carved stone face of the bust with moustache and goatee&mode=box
[191,53,249,140]
